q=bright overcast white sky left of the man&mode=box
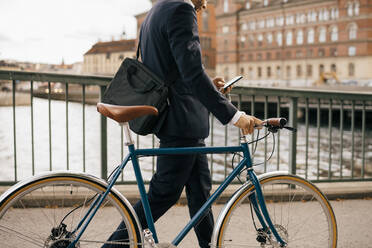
[0,0,151,64]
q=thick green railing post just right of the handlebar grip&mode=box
[288,97,298,175]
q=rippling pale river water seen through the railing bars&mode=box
[0,98,372,181]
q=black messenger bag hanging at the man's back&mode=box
[102,40,178,135]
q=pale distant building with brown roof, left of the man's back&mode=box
[82,39,136,75]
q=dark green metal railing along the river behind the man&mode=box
[0,70,372,185]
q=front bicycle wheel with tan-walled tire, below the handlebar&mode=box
[211,172,337,248]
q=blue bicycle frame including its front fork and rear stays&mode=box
[68,137,286,248]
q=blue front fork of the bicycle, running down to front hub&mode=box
[248,169,287,247]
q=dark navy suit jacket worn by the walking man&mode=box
[140,0,237,140]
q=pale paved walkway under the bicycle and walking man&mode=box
[0,182,372,248]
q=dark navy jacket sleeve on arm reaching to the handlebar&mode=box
[167,3,237,124]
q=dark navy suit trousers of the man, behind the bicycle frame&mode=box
[103,139,214,248]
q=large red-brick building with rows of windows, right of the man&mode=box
[215,0,372,86]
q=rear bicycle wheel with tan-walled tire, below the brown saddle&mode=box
[0,172,143,248]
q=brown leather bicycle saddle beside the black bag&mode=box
[97,102,158,123]
